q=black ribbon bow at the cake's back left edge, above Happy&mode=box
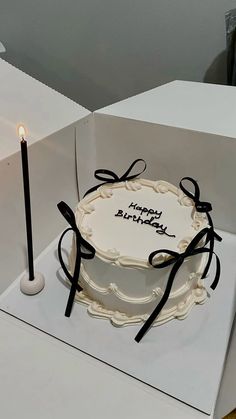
[84,159,147,197]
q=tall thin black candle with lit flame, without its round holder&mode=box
[19,126,34,281]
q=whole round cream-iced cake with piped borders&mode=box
[70,179,208,326]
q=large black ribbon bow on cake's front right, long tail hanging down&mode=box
[135,228,220,342]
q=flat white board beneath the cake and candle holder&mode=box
[0,232,236,415]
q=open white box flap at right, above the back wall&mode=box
[95,80,236,138]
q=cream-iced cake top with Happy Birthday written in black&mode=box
[76,179,207,266]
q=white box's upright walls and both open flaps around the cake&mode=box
[0,61,236,417]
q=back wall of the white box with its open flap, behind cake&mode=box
[74,81,236,417]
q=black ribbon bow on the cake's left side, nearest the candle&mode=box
[57,201,95,317]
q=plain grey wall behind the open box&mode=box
[0,0,236,110]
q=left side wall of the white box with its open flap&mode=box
[0,59,90,292]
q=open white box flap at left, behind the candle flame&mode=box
[0,59,90,160]
